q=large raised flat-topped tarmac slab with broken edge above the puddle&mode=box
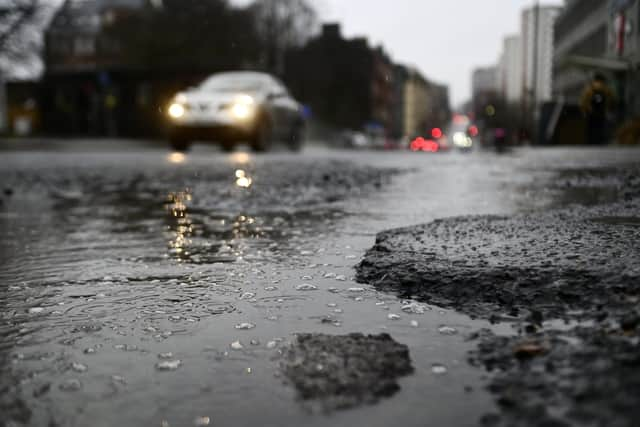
[357,201,640,321]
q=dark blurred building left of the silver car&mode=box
[42,0,162,136]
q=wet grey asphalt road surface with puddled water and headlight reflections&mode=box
[0,141,640,426]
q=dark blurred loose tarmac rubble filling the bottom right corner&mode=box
[470,327,640,427]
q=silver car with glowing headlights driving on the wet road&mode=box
[166,71,305,151]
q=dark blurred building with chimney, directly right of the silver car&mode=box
[285,24,395,134]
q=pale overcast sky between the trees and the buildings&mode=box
[311,0,562,106]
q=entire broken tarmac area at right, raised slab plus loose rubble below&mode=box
[357,167,640,427]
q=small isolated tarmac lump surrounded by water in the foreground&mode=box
[281,334,413,411]
